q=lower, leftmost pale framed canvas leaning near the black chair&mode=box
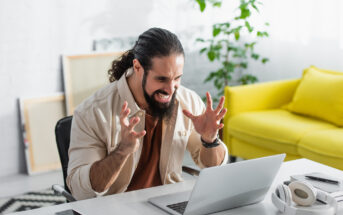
[19,93,66,175]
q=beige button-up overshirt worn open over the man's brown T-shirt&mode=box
[67,70,228,200]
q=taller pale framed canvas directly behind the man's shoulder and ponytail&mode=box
[63,52,123,115]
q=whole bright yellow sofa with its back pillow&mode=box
[223,66,343,170]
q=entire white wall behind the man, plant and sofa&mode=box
[0,0,343,177]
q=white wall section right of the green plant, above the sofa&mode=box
[249,0,343,81]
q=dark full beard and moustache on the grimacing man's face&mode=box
[142,73,177,119]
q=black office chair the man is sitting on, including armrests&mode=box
[52,116,200,202]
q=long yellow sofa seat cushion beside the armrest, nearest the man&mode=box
[225,109,337,155]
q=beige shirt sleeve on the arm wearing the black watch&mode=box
[187,93,229,169]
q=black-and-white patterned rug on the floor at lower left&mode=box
[0,188,66,214]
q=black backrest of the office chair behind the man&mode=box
[55,116,73,193]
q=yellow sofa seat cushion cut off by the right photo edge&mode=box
[298,129,343,169]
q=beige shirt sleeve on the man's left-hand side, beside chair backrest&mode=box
[67,111,107,200]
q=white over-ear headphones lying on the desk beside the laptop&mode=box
[272,181,337,215]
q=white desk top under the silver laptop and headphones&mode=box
[12,159,343,215]
